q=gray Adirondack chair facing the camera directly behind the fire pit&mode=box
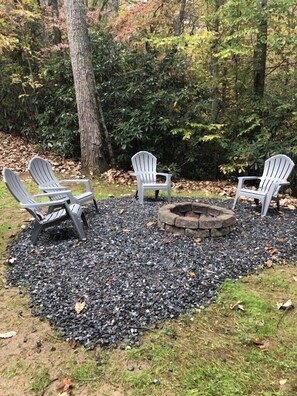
[131,151,171,204]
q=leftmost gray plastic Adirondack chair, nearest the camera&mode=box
[3,168,87,245]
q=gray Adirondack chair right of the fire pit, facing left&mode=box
[232,154,294,217]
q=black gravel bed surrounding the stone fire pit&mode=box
[7,197,297,349]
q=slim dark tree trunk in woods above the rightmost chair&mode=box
[254,0,267,98]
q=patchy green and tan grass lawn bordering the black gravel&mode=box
[0,180,297,396]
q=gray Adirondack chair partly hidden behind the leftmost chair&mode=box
[28,157,99,213]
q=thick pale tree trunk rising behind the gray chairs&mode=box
[64,0,108,175]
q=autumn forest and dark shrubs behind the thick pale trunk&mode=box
[0,0,297,190]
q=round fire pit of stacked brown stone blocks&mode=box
[158,202,235,238]
